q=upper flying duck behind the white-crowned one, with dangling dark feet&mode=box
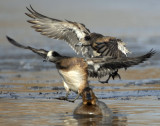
[26,6,129,83]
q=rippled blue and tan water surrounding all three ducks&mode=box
[0,0,160,126]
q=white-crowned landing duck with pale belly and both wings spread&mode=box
[6,36,155,102]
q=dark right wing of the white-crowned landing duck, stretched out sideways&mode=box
[87,50,155,78]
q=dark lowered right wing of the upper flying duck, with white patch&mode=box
[91,33,129,58]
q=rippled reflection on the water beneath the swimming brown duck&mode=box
[64,108,127,126]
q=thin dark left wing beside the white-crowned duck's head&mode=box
[6,36,48,59]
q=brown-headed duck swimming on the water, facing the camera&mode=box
[73,87,113,117]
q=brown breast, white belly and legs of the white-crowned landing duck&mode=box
[55,57,89,101]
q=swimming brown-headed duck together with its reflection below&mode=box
[68,87,127,126]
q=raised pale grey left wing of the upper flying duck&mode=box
[26,6,90,56]
